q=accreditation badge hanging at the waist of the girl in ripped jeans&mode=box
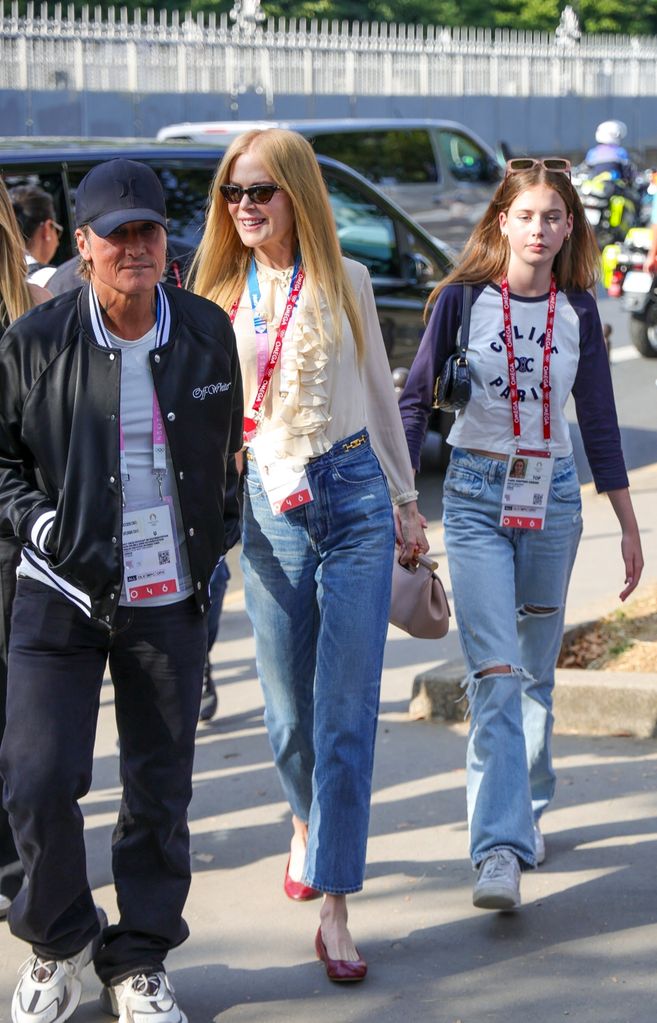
[499,448,555,529]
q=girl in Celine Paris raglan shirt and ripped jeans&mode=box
[401,158,643,909]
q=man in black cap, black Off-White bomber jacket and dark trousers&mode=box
[0,160,243,1023]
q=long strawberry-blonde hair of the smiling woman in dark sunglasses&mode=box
[188,128,364,358]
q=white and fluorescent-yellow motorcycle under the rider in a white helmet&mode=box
[573,168,640,249]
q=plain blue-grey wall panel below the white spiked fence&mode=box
[0,89,657,163]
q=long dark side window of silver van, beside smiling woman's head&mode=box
[310,128,437,186]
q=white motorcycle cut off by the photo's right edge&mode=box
[612,227,657,359]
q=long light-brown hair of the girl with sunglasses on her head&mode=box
[425,165,600,318]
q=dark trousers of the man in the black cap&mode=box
[0,578,208,983]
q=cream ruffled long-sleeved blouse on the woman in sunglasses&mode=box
[233,260,415,503]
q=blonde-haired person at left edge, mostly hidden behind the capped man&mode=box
[0,178,50,920]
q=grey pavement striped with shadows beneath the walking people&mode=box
[0,454,657,1023]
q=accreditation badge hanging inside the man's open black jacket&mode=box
[123,501,180,604]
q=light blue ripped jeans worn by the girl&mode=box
[443,448,582,866]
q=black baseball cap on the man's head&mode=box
[76,160,167,238]
